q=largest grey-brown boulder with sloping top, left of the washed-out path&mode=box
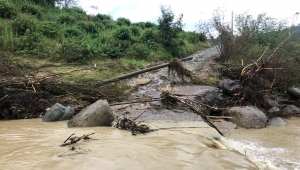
[68,100,114,127]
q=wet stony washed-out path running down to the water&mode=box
[112,45,218,121]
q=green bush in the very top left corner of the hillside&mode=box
[0,0,17,19]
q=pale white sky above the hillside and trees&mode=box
[80,0,300,31]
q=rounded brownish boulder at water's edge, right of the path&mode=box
[225,106,267,128]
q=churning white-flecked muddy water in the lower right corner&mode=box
[225,118,300,170]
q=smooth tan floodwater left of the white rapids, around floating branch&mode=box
[0,119,256,170]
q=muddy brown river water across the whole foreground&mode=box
[0,119,300,170]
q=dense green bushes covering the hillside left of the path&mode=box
[0,0,208,63]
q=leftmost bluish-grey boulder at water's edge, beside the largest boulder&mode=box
[42,103,75,122]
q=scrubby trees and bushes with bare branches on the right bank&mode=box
[198,10,300,104]
